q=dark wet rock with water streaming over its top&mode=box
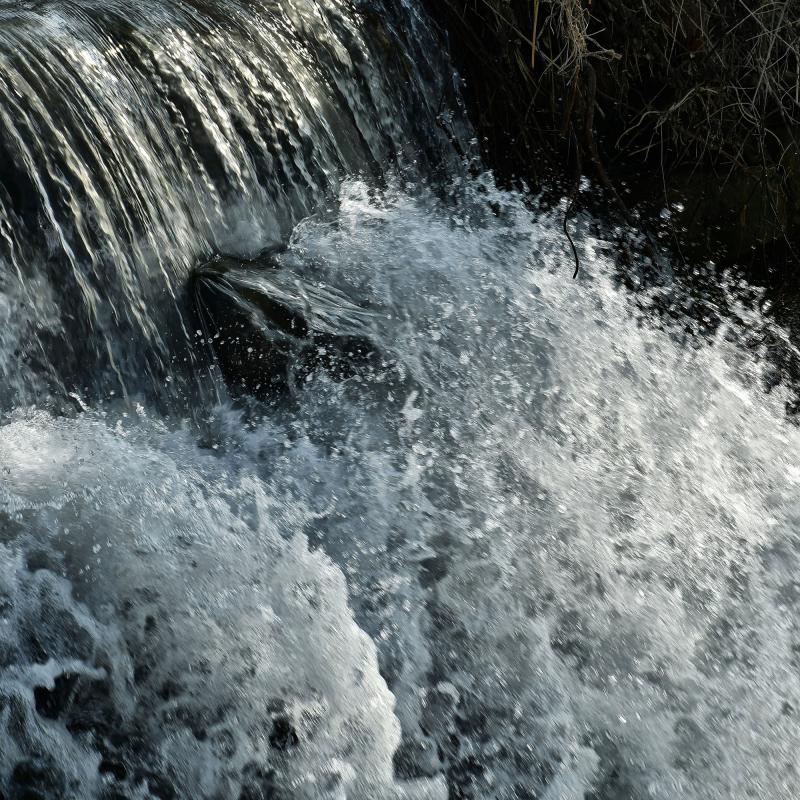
[190,257,380,399]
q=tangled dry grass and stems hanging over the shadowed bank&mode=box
[431,0,800,252]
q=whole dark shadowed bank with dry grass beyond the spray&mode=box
[426,0,800,300]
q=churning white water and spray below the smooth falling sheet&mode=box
[0,181,800,800]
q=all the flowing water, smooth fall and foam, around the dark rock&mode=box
[0,0,800,800]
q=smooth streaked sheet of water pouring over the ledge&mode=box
[0,2,463,410]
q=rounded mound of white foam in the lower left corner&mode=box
[0,413,441,798]
